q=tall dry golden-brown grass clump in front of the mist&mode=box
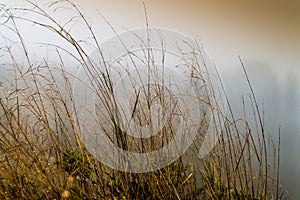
[0,0,287,199]
